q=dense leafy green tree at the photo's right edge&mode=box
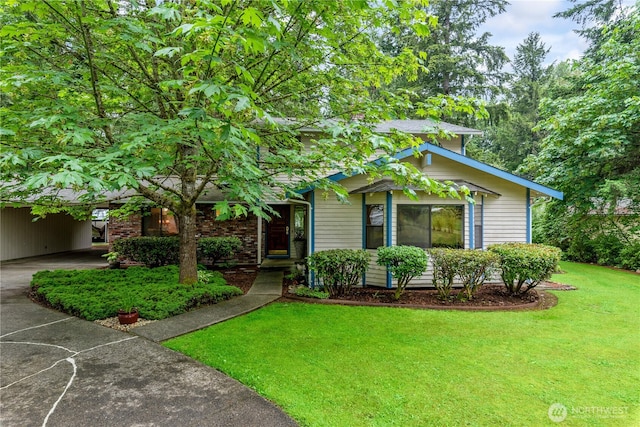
[526,5,640,248]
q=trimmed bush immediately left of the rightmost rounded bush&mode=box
[455,249,500,299]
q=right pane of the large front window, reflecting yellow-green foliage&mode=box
[431,205,464,248]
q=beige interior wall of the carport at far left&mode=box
[0,208,91,261]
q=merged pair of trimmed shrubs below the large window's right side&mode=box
[431,248,500,299]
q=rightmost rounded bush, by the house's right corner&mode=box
[489,243,561,295]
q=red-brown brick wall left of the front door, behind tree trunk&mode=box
[109,205,258,265]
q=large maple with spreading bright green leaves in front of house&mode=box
[0,0,476,283]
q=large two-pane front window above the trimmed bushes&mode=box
[397,205,464,248]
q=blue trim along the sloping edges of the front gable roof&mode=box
[314,142,564,200]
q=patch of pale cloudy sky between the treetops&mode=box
[480,0,587,64]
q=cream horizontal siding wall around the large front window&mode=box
[315,149,527,287]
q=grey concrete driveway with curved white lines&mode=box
[0,251,296,427]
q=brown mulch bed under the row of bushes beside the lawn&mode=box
[282,281,575,310]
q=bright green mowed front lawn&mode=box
[166,263,640,426]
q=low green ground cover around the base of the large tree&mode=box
[31,265,242,320]
